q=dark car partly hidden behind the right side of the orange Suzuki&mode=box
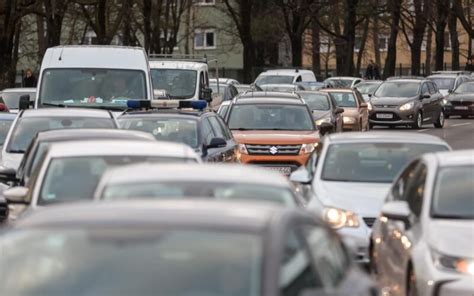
[297,91,344,132]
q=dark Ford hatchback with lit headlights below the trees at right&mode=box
[369,78,444,129]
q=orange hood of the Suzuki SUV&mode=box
[232,130,319,145]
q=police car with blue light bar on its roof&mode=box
[118,100,237,162]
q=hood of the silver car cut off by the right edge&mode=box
[427,219,474,258]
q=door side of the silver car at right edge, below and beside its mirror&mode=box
[378,162,427,289]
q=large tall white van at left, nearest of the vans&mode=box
[26,45,153,109]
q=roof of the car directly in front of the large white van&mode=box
[20,108,112,119]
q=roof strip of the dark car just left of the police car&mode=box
[36,128,156,141]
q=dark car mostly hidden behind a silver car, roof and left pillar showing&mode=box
[16,129,155,186]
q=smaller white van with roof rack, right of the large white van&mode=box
[150,55,212,101]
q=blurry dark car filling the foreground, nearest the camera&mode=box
[0,198,377,296]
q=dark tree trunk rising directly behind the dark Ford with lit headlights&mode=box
[383,0,402,78]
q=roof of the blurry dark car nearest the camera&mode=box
[13,198,301,231]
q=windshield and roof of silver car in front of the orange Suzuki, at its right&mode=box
[322,142,448,183]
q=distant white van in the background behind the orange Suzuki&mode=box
[255,69,316,86]
